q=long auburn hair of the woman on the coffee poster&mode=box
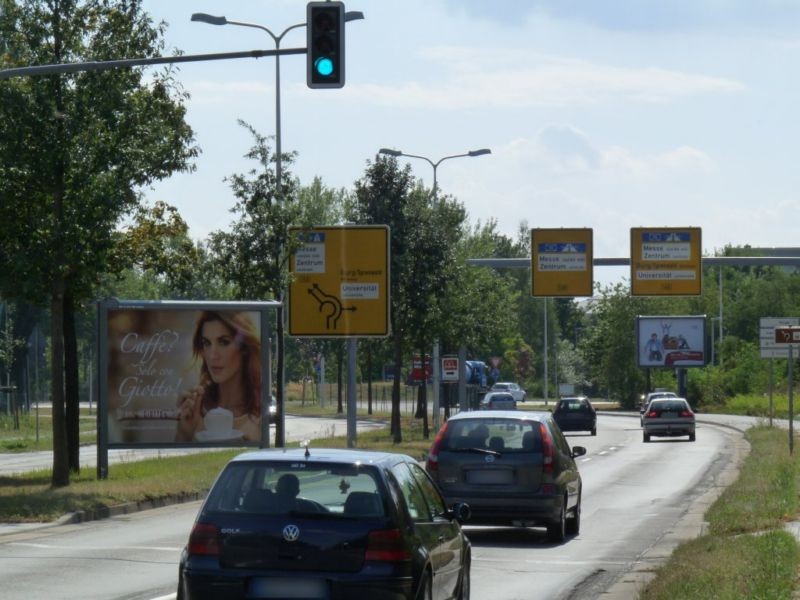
[192,310,261,417]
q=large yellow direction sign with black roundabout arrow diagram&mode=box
[289,225,389,337]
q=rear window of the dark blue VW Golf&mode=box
[204,462,385,518]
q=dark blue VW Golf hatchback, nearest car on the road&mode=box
[177,448,471,600]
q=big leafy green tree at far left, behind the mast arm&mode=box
[0,0,197,487]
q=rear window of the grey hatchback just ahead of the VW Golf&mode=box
[441,418,542,453]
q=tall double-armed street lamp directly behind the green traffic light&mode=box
[192,11,364,446]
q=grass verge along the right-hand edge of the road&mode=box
[640,427,800,600]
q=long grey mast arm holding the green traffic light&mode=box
[0,48,306,80]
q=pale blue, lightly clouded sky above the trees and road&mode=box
[138,0,800,284]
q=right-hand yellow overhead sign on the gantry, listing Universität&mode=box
[631,227,703,296]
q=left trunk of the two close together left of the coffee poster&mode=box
[50,278,69,487]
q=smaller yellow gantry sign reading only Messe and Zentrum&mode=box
[531,229,594,296]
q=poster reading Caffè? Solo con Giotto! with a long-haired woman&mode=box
[104,309,268,446]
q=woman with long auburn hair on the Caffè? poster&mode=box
[175,311,261,442]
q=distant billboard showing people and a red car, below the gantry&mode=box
[636,315,706,368]
